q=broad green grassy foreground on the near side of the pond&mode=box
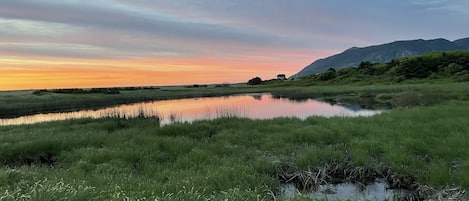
[0,100,469,200]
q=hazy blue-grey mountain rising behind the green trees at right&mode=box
[292,38,469,78]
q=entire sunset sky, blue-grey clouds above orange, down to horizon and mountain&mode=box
[0,0,469,90]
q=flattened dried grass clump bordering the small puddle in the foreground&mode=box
[275,162,465,201]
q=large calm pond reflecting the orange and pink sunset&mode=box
[0,93,382,126]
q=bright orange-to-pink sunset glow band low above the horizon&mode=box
[0,53,318,90]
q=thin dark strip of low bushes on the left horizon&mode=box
[33,87,159,95]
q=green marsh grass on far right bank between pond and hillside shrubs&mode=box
[270,83,469,109]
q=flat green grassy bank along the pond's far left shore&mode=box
[0,85,264,118]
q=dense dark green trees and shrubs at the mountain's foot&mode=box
[302,51,469,83]
